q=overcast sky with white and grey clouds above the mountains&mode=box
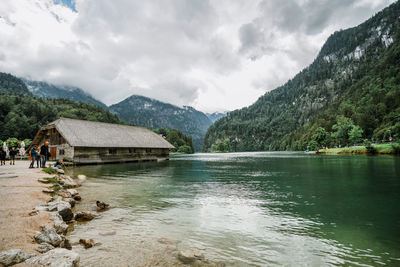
[0,0,394,112]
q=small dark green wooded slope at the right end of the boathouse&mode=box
[154,128,194,154]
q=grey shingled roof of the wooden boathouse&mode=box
[35,118,174,148]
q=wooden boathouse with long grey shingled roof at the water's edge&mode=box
[32,118,174,165]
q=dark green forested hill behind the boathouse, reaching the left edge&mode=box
[0,94,122,140]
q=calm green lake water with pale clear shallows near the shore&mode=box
[70,153,400,266]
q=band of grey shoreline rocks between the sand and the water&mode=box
[0,166,93,267]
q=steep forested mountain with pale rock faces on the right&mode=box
[204,1,400,151]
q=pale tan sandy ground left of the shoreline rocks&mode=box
[0,161,52,254]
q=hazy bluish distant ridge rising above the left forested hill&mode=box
[21,79,107,108]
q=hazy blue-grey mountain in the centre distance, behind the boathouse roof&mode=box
[109,95,212,151]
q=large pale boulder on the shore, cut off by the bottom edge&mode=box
[25,248,80,267]
